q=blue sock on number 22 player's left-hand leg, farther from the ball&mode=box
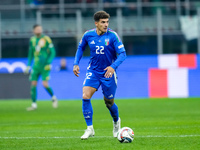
[82,99,93,126]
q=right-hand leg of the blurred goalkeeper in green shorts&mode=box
[42,71,58,108]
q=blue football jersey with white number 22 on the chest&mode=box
[74,28,125,72]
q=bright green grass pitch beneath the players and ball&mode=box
[0,98,200,150]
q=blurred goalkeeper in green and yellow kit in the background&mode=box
[24,24,58,111]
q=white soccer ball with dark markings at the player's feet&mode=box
[117,127,134,143]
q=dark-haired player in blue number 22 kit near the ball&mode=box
[73,11,126,139]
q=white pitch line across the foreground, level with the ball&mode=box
[0,134,200,140]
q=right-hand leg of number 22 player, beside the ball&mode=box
[102,73,121,137]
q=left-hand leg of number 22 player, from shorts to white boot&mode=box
[81,71,100,139]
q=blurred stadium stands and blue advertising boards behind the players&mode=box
[0,0,200,99]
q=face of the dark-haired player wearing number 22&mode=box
[95,18,109,35]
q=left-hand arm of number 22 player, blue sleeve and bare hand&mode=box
[73,35,87,77]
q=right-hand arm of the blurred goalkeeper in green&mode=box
[44,36,56,70]
